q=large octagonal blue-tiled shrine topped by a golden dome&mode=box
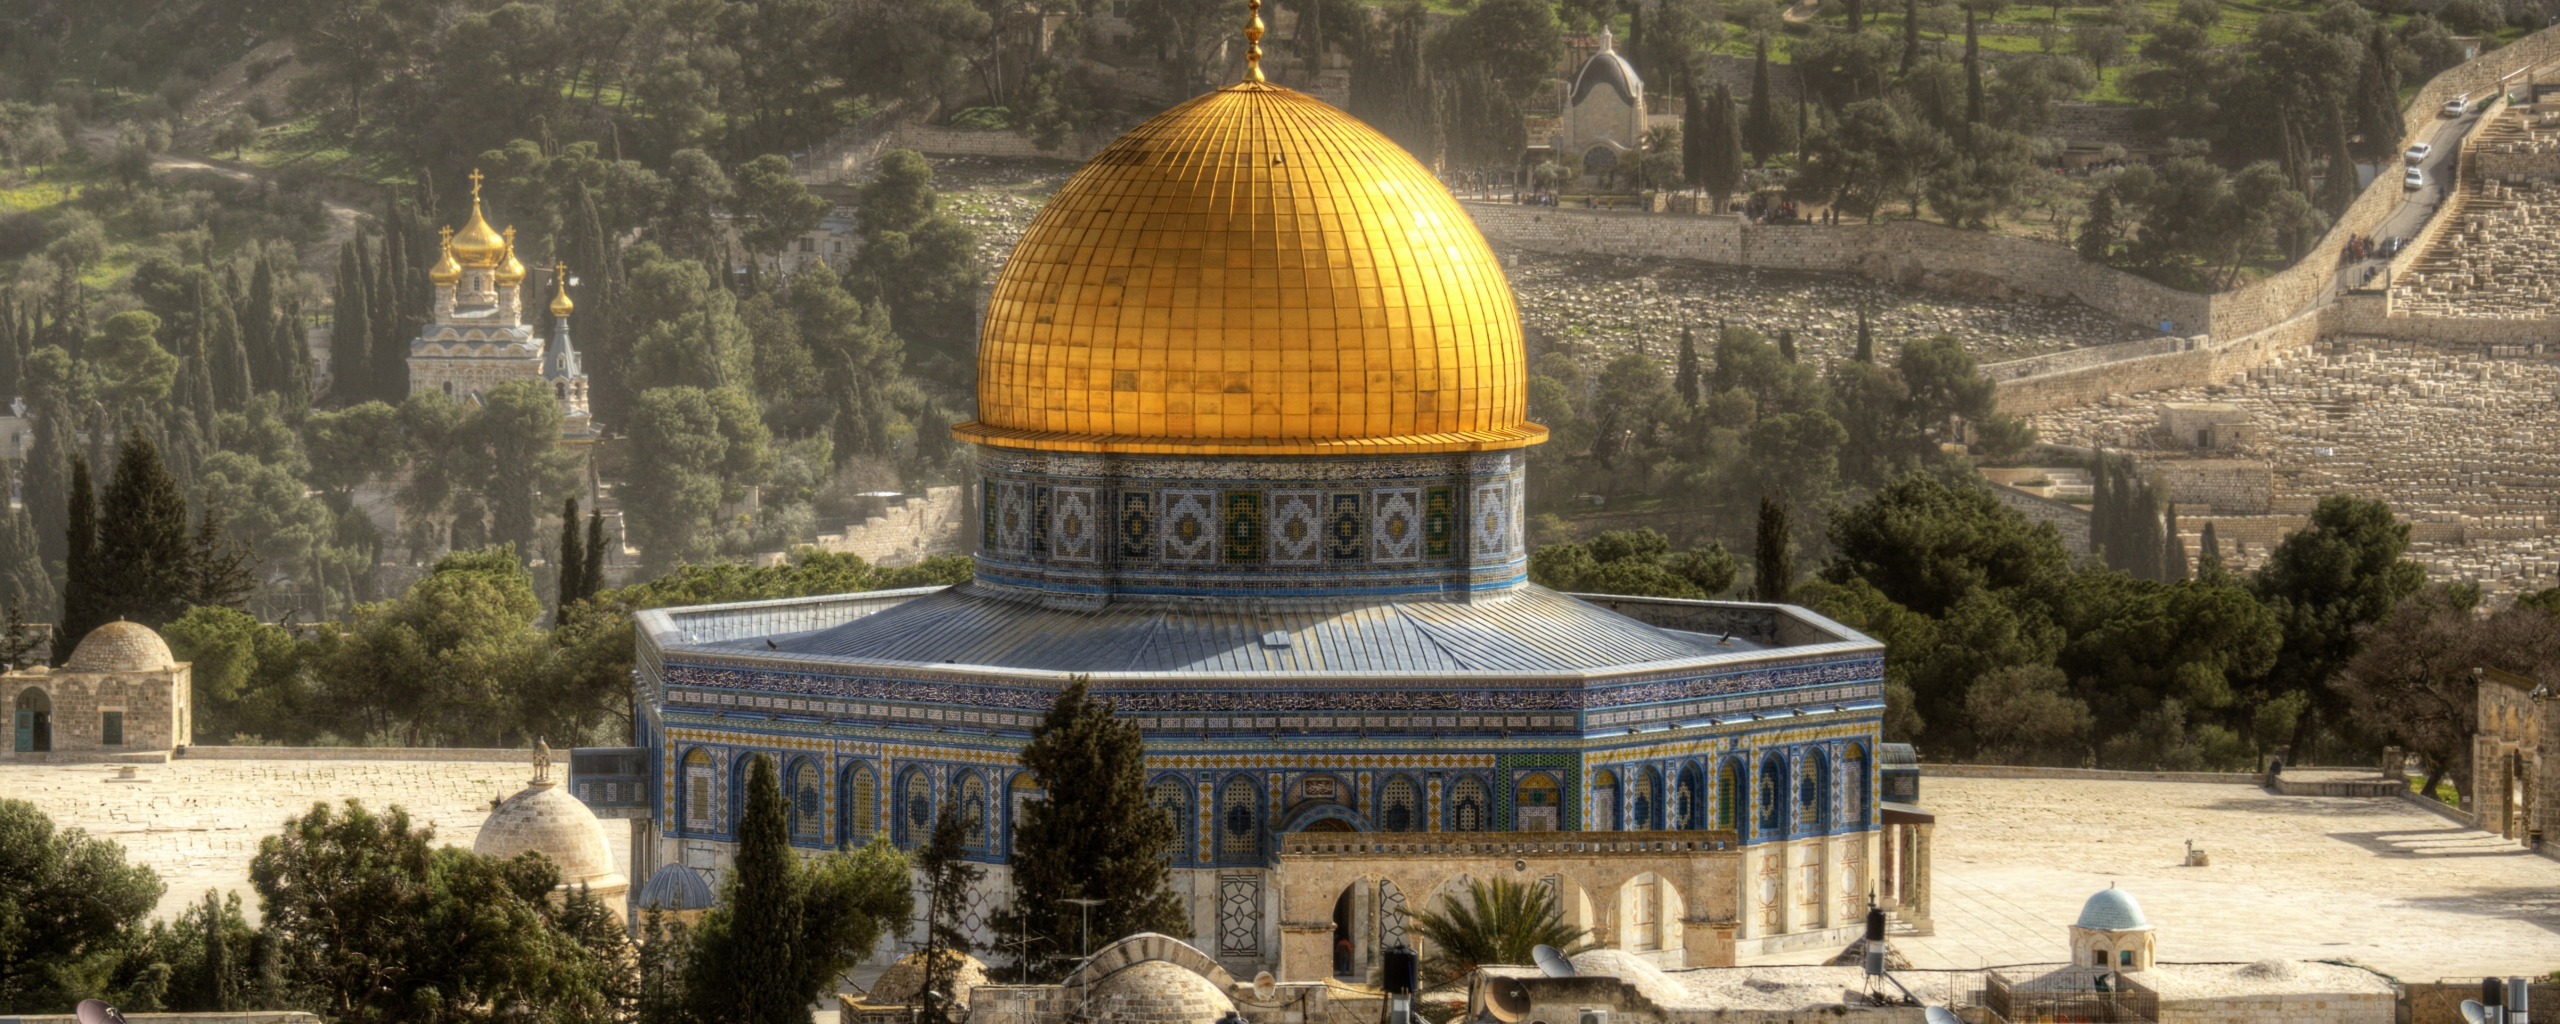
[622,8,1894,983]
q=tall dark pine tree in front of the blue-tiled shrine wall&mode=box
[996,676,1190,973]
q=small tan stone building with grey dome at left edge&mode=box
[0,620,195,760]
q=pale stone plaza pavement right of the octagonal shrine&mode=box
[1751,773,2560,980]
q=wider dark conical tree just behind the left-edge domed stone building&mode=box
[92,430,192,630]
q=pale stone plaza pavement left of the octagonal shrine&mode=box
[0,758,630,919]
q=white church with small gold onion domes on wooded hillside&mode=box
[410,172,596,440]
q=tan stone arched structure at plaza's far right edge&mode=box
[2463,668,2560,845]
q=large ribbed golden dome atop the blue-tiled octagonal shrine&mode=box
[952,82,1546,456]
